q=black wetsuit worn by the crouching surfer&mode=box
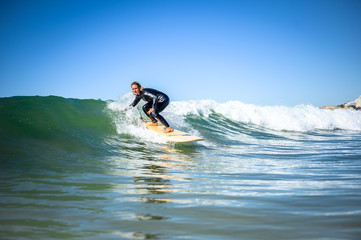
[131,88,169,127]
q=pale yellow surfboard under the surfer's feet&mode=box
[143,122,203,143]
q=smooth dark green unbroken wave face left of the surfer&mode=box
[0,96,116,165]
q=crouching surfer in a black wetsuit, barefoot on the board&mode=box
[130,82,173,133]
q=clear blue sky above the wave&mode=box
[0,0,361,106]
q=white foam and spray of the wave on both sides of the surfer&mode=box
[108,94,361,135]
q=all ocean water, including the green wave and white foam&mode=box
[0,94,361,240]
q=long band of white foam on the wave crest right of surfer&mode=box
[173,100,361,131]
